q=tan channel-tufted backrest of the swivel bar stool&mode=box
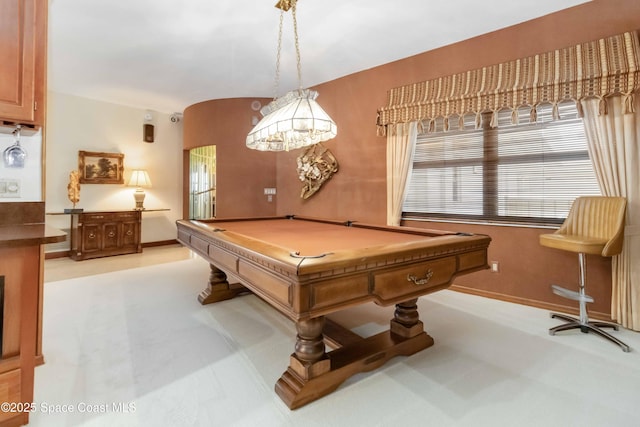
[557,196,627,257]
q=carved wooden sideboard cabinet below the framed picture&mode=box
[69,210,142,261]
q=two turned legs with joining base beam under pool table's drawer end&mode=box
[275,299,433,409]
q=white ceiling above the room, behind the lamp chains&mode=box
[48,0,585,113]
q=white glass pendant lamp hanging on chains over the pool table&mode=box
[247,0,338,151]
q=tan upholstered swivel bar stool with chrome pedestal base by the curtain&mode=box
[540,197,629,352]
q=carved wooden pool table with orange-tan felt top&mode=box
[177,215,491,409]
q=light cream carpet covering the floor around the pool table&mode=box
[30,259,640,427]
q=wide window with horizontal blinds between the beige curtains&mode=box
[403,102,600,223]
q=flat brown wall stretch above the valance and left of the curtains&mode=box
[277,0,640,223]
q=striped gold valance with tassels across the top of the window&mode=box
[377,32,640,136]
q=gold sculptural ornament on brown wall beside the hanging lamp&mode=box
[297,143,338,199]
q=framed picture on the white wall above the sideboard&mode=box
[78,151,124,184]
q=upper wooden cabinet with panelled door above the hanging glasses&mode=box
[0,0,47,127]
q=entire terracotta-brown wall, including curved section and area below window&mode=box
[184,0,640,317]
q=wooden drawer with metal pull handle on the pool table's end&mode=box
[373,257,457,300]
